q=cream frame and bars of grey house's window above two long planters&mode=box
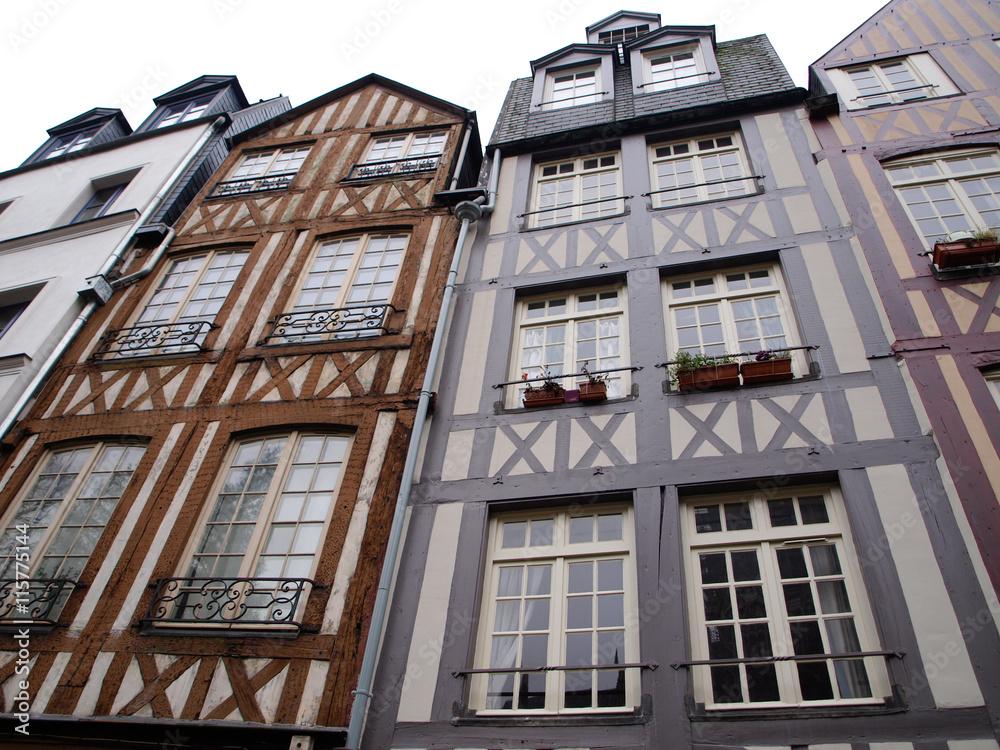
[663,263,807,373]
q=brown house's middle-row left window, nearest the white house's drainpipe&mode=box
[111,249,250,357]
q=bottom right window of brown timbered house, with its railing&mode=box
[159,431,351,626]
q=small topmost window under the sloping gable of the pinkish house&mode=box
[828,54,958,109]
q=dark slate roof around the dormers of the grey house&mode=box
[490,34,805,145]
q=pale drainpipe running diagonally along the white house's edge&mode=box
[0,115,229,440]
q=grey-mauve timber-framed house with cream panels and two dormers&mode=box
[363,5,1000,750]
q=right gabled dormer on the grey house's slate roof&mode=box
[624,26,720,96]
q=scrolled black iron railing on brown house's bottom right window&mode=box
[141,578,317,630]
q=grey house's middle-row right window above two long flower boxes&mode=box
[664,265,796,356]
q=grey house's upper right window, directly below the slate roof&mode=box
[649,132,757,208]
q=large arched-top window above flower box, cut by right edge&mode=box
[882,148,1000,247]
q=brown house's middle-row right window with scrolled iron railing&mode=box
[268,234,409,343]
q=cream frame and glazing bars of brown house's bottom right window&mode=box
[172,430,354,629]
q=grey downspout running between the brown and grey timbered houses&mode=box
[345,149,500,750]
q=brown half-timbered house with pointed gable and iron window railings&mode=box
[0,75,482,748]
